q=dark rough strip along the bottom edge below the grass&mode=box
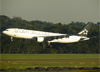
[0,67,99,72]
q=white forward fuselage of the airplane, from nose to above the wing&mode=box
[3,28,66,39]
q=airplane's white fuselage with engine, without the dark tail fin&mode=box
[3,28,89,43]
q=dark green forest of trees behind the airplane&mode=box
[0,15,99,54]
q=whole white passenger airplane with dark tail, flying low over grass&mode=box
[3,23,92,44]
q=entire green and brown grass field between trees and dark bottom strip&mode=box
[0,54,100,69]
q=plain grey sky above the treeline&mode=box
[1,0,99,24]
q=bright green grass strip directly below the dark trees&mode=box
[0,54,99,59]
